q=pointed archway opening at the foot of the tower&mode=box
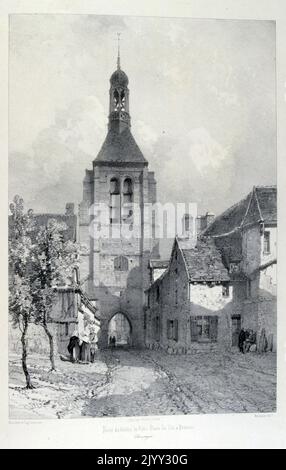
[108,313,131,347]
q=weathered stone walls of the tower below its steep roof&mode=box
[80,164,156,348]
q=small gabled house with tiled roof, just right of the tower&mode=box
[145,238,234,354]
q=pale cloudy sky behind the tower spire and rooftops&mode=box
[9,14,276,218]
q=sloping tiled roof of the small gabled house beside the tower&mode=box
[178,237,230,282]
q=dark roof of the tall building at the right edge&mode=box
[203,186,277,236]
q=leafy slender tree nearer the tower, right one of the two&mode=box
[32,219,78,370]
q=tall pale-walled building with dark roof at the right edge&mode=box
[204,186,277,350]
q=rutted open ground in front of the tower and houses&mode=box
[10,350,276,419]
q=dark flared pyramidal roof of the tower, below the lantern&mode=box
[93,127,148,165]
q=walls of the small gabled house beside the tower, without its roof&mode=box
[146,239,235,354]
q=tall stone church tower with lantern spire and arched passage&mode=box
[79,46,156,347]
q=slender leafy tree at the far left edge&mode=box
[9,196,34,388]
